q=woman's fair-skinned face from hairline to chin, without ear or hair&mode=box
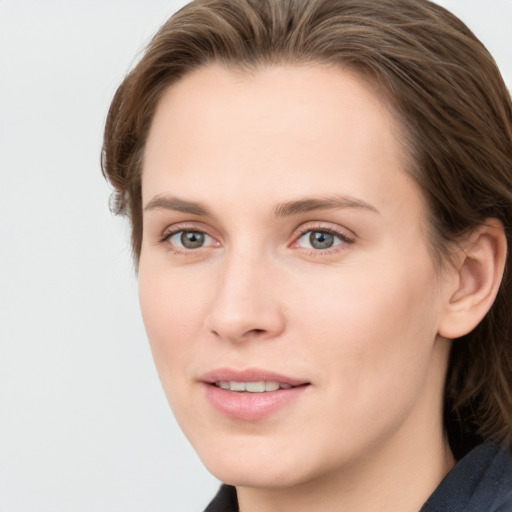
[139,65,448,487]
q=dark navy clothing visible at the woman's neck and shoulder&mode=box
[204,444,512,512]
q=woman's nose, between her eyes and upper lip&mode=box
[205,251,285,343]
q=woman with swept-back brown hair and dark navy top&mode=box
[103,0,512,512]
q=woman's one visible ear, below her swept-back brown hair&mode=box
[438,219,507,339]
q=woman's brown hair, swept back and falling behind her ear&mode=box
[102,0,512,456]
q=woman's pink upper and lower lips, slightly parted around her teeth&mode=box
[199,368,310,421]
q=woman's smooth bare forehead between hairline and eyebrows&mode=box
[143,64,420,218]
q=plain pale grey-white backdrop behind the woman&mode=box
[0,0,512,512]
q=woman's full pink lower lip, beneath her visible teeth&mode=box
[204,383,309,421]
